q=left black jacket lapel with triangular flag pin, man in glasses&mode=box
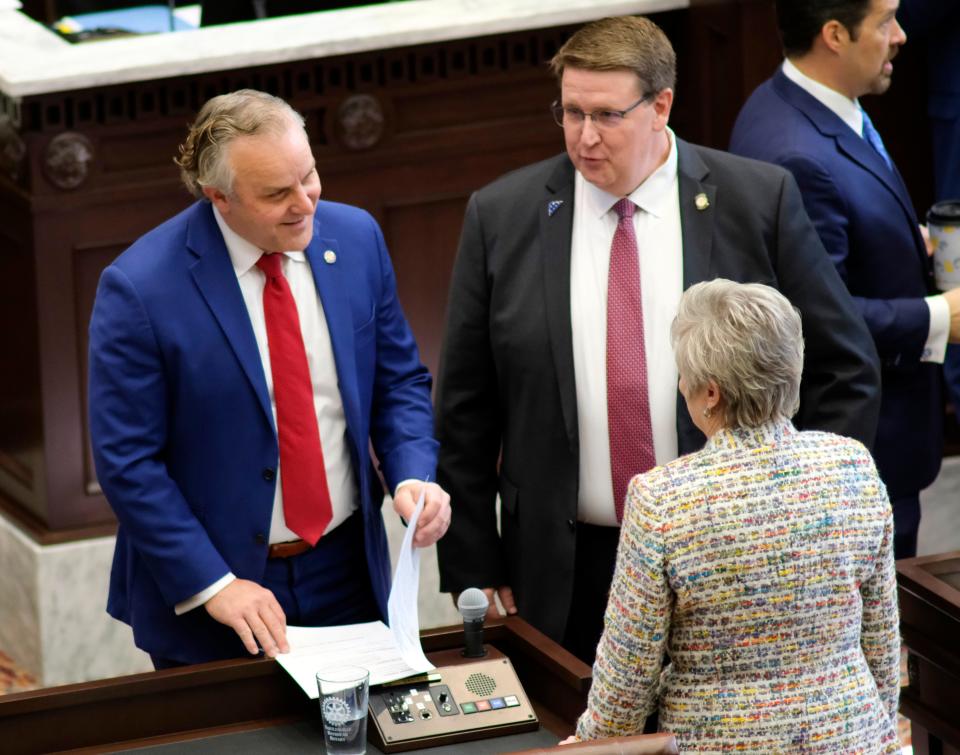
[537,156,579,452]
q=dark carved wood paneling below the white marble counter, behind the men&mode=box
[0,0,868,540]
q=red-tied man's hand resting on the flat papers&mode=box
[204,579,290,658]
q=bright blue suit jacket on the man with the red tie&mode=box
[89,202,437,662]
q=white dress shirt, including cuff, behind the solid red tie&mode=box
[176,208,359,614]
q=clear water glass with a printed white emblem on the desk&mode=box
[317,666,370,755]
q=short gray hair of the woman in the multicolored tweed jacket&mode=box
[670,278,803,427]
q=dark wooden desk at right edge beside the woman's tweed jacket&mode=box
[897,551,960,755]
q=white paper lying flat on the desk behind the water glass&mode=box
[277,621,433,699]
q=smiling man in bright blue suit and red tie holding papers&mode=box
[89,90,450,668]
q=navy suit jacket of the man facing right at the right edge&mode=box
[730,70,943,498]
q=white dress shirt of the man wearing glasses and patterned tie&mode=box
[570,129,683,526]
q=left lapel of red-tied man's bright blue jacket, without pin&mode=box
[187,202,276,429]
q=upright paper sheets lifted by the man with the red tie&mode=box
[387,484,433,671]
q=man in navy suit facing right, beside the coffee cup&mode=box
[730,0,960,558]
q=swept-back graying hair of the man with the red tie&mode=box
[174,89,304,199]
